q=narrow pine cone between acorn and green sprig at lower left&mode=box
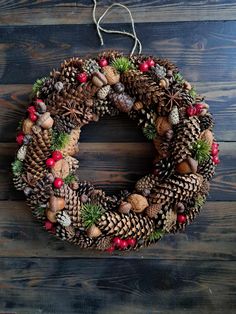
[55,185,82,228]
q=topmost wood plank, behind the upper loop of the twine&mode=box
[0,0,236,25]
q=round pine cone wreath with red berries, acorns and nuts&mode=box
[12,51,219,252]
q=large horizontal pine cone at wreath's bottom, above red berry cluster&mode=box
[97,211,154,240]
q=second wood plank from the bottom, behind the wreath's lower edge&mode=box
[0,201,236,261]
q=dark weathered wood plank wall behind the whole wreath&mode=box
[0,0,236,314]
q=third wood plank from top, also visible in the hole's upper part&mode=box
[0,81,236,143]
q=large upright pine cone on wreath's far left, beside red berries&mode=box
[24,130,52,180]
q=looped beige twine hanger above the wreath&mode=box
[93,0,142,57]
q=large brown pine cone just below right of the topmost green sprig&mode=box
[121,70,163,106]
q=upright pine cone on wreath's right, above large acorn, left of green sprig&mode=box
[172,116,201,164]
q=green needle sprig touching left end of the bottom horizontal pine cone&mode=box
[81,203,104,229]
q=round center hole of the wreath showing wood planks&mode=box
[77,114,154,194]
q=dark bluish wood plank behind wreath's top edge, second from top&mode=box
[0,21,236,84]
